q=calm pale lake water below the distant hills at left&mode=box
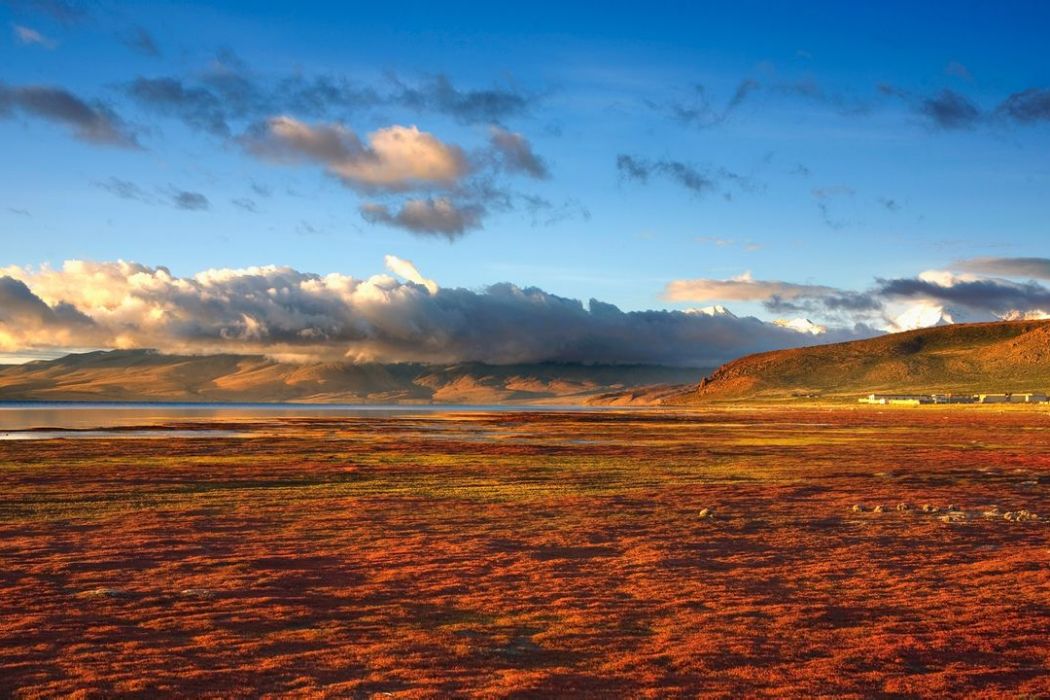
[0,402,600,432]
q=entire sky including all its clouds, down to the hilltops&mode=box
[0,0,1050,365]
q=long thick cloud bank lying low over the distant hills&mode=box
[0,260,858,366]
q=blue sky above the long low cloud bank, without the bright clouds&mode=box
[0,0,1050,367]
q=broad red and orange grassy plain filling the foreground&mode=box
[0,407,1050,697]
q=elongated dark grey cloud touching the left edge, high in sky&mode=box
[0,83,139,148]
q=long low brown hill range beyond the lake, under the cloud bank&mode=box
[0,351,705,404]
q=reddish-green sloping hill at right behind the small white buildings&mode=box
[684,321,1050,403]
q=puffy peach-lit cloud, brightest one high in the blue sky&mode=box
[245,116,469,192]
